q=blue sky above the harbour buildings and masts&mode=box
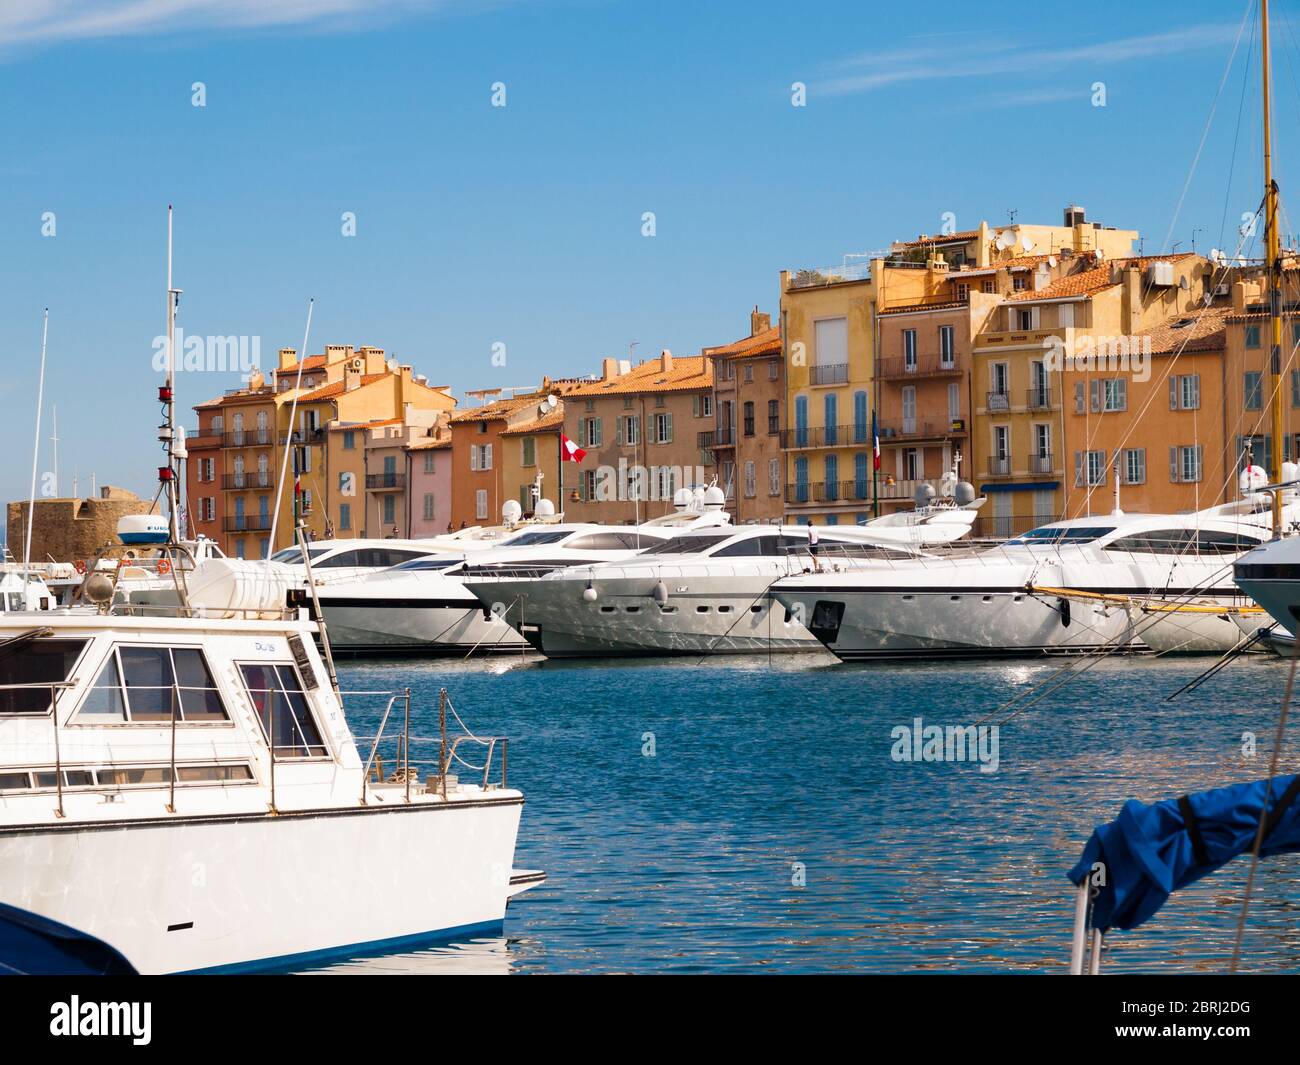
[0,0,1300,517]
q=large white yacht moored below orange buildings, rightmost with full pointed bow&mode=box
[772,497,1284,661]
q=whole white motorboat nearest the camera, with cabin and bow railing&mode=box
[0,560,541,973]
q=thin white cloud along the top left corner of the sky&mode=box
[0,0,488,47]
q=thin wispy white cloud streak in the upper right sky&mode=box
[814,23,1239,96]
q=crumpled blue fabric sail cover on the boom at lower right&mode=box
[1070,776,1300,931]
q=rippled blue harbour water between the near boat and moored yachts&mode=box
[295,655,1300,973]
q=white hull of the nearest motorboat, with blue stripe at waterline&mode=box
[0,791,523,973]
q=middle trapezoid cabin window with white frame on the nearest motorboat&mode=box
[77,646,229,724]
